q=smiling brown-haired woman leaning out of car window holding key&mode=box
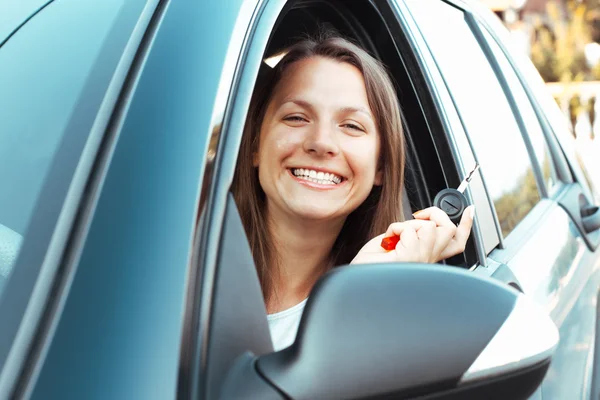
[232,33,472,349]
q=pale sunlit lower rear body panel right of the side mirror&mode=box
[490,200,600,399]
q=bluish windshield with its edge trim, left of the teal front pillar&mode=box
[0,0,156,398]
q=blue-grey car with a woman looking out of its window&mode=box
[0,0,600,399]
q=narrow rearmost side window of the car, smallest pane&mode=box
[481,27,558,195]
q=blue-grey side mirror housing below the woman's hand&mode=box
[255,264,559,399]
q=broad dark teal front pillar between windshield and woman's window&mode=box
[27,1,262,399]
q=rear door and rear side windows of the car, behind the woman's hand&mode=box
[407,1,599,399]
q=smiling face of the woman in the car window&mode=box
[254,57,381,220]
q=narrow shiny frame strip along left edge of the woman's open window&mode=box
[178,0,291,398]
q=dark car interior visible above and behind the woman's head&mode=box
[233,0,477,268]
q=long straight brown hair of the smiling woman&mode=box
[232,33,404,301]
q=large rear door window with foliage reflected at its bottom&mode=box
[407,0,540,236]
